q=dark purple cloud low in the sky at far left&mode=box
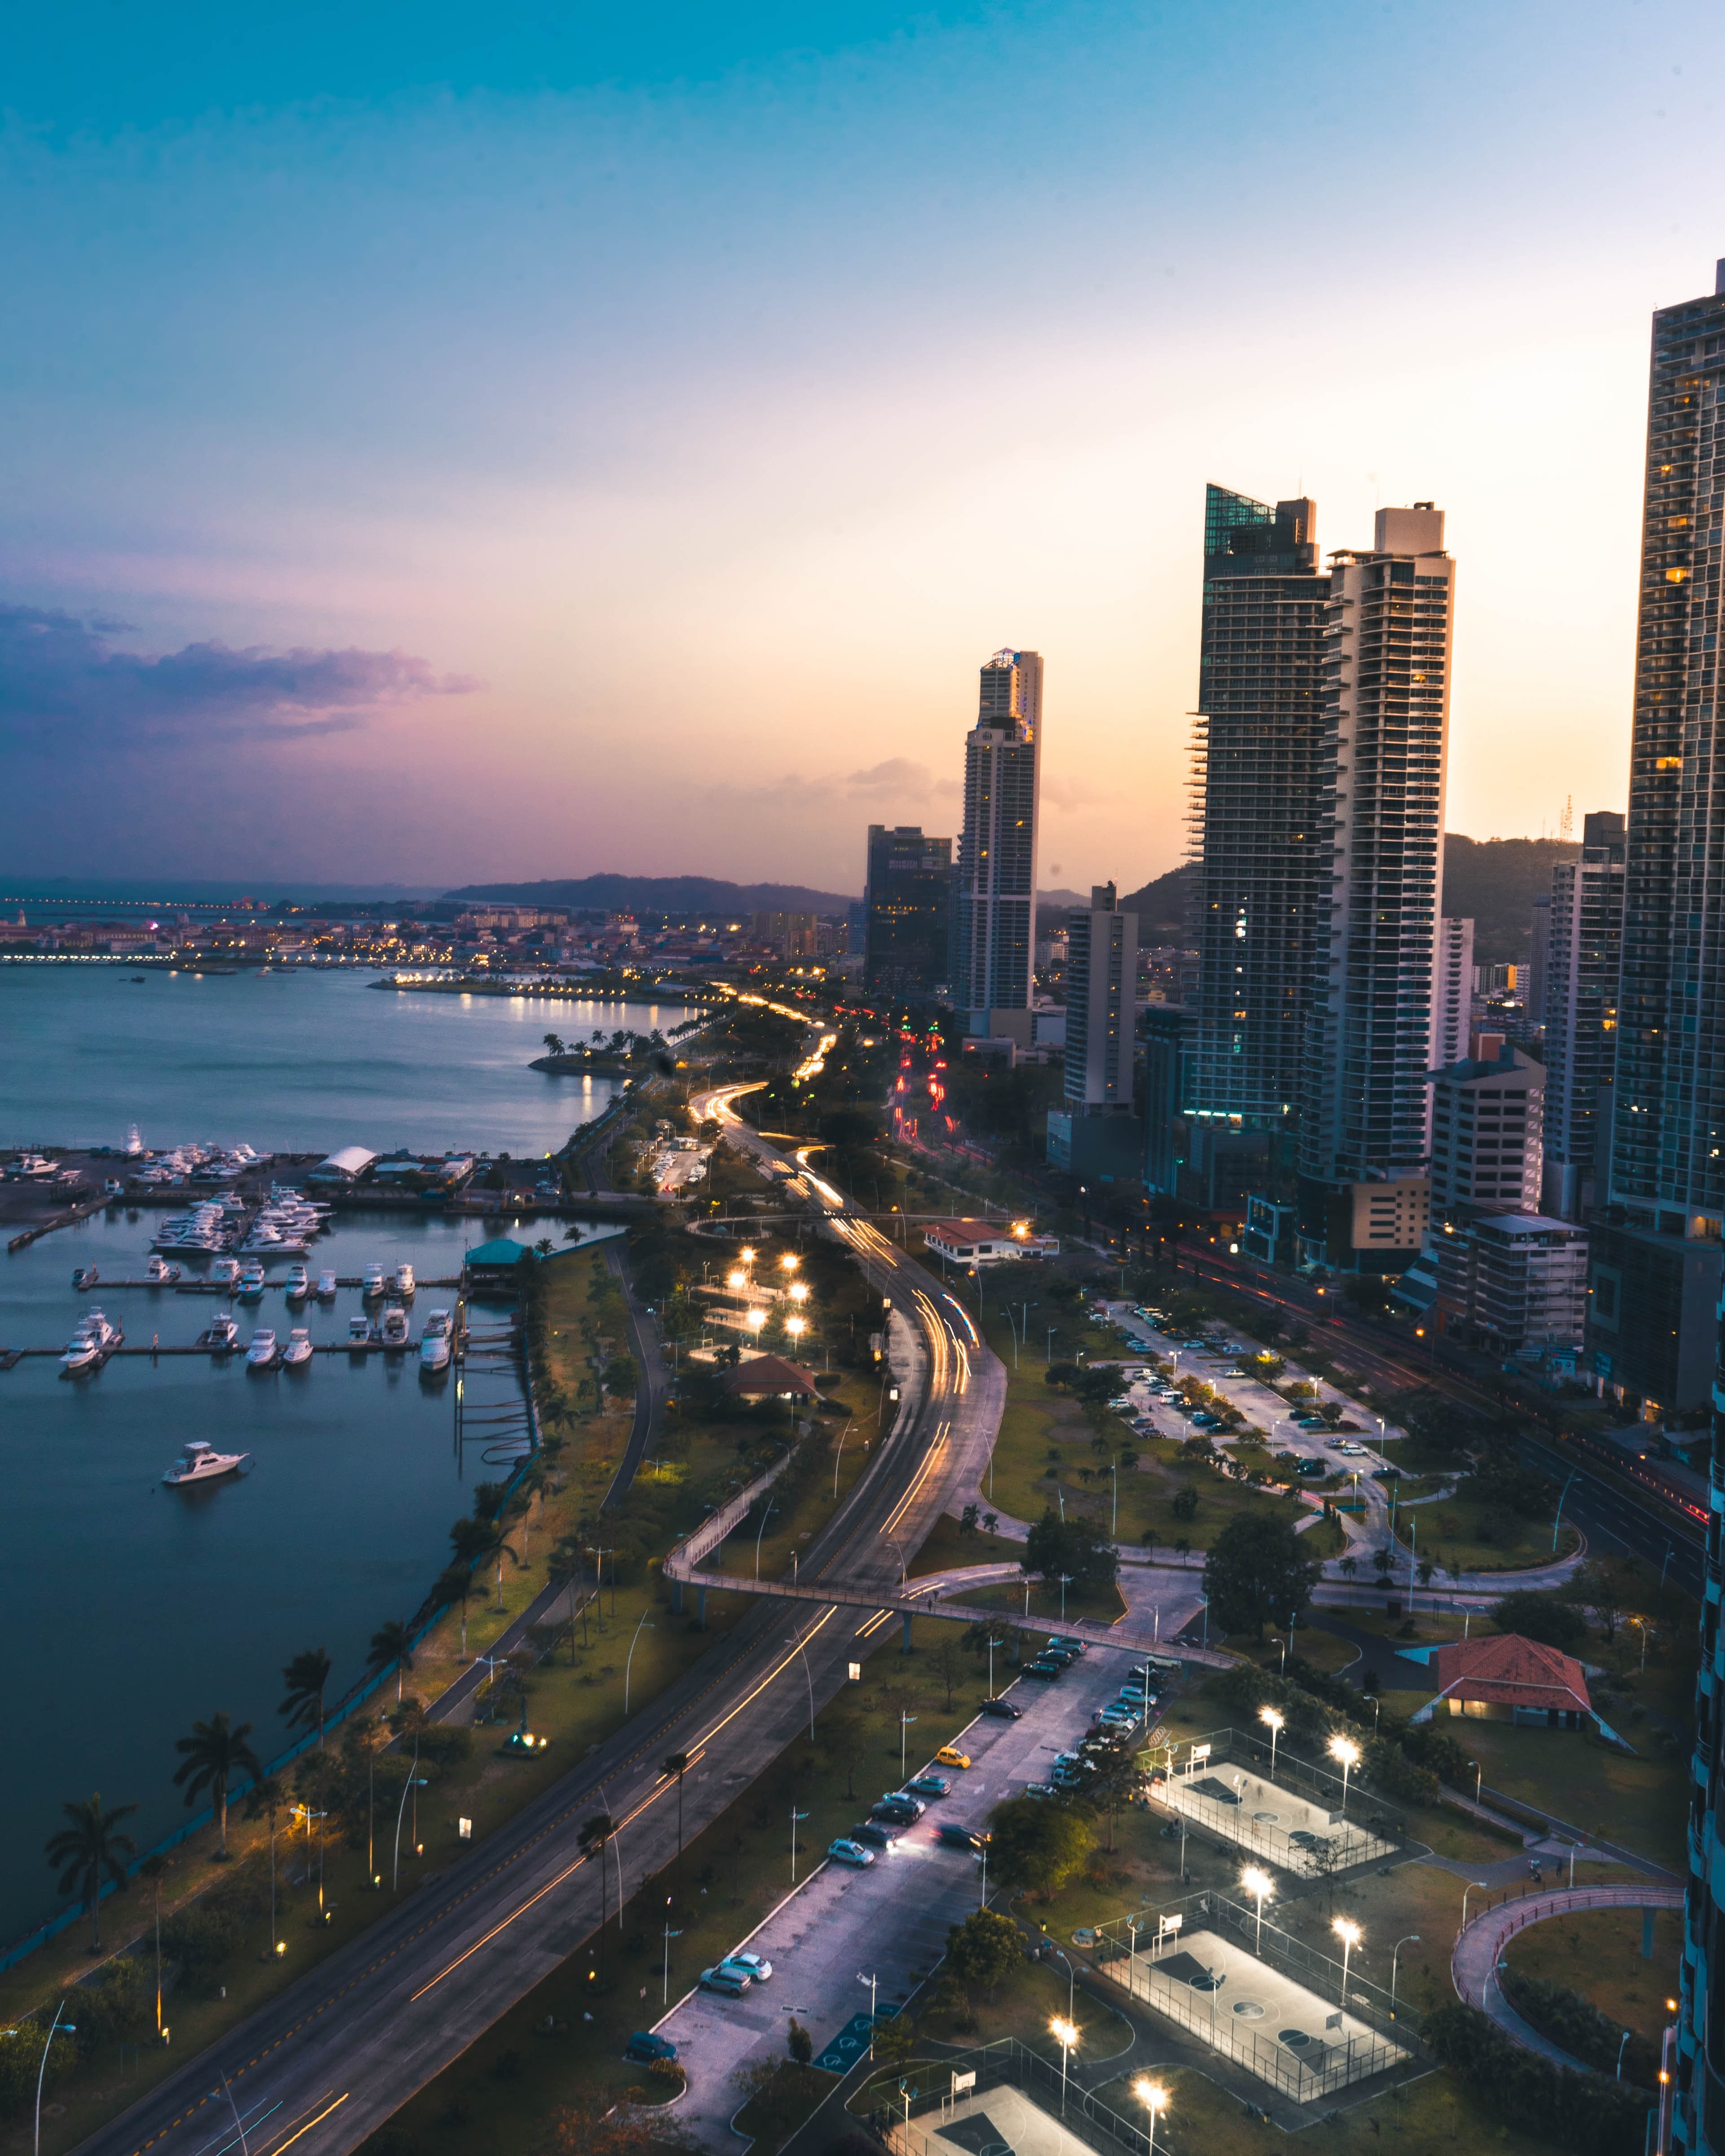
[0,606,481,748]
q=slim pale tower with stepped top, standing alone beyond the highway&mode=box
[949,651,1041,1046]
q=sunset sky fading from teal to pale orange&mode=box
[0,0,1725,892]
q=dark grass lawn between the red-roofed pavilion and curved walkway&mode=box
[1442,1716,1688,1869]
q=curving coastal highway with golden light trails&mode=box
[80,1089,1005,2156]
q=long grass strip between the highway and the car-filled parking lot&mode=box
[390,1619,1031,2156]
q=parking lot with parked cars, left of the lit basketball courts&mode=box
[653,1647,1173,2150]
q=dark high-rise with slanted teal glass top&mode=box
[1181,485,1331,1166]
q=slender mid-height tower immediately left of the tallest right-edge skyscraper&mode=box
[1539,811,1623,1220]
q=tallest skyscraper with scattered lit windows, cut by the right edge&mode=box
[1587,270,1725,1423]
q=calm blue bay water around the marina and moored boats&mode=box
[0,966,688,1947]
